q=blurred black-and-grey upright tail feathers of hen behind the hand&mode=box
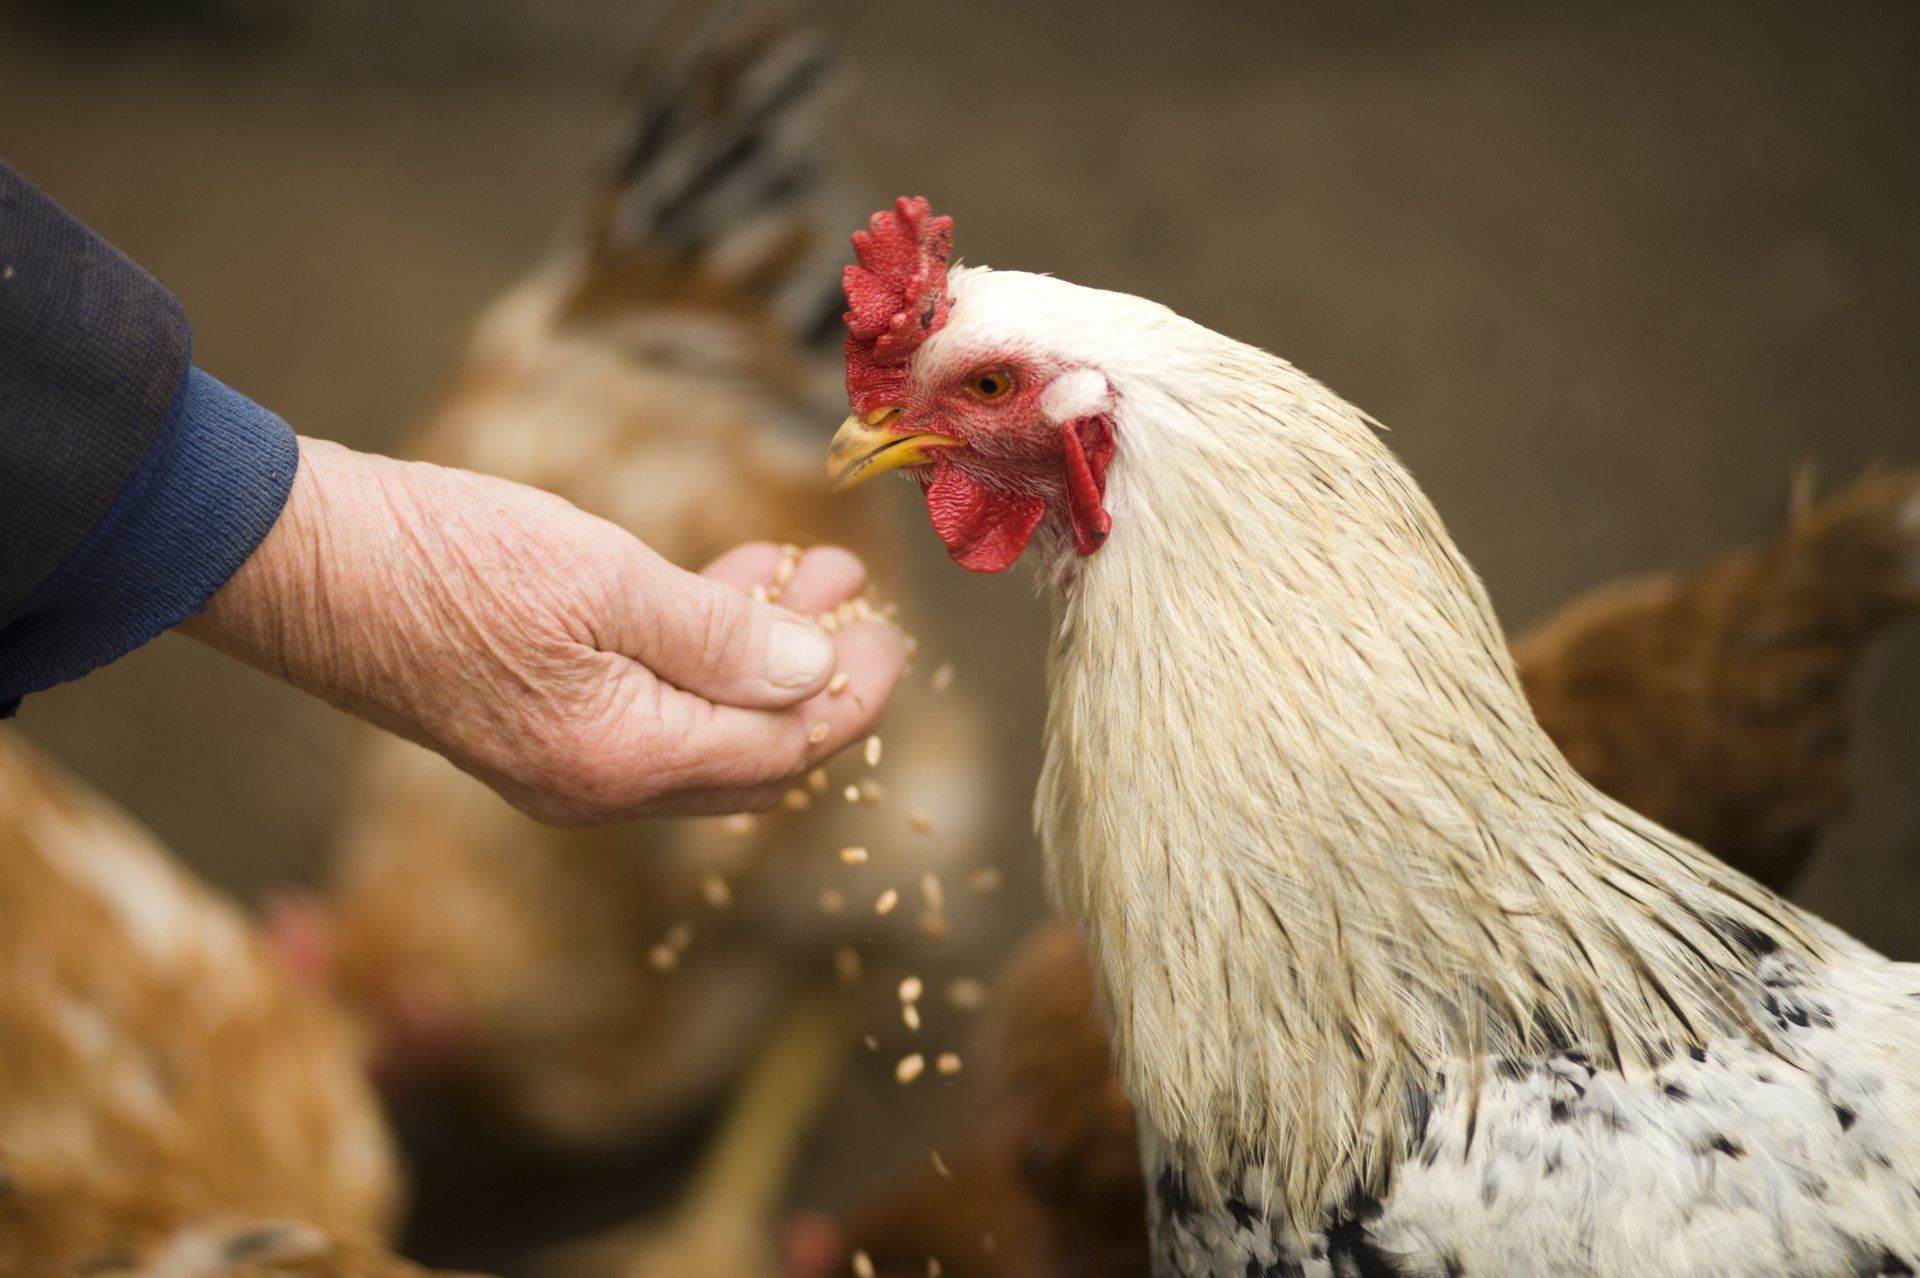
[572,4,849,342]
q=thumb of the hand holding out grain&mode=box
[620,558,835,710]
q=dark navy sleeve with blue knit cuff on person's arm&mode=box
[0,165,298,718]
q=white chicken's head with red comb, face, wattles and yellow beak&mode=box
[828,198,1114,572]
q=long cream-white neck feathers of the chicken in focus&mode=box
[1039,328,1816,1226]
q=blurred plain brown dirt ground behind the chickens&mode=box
[0,0,1920,1265]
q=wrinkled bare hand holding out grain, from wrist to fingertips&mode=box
[180,439,906,825]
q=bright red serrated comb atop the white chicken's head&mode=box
[841,196,954,414]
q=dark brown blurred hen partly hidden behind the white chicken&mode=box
[833,472,1920,1278]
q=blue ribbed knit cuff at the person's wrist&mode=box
[0,368,300,718]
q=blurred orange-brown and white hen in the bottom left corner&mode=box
[0,733,456,1278]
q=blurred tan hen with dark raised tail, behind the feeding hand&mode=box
[311,7,991,1166]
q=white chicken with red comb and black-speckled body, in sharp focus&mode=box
[829,200,1920,1278]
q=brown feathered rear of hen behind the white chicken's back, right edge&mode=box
[1513,472,1920,887]
